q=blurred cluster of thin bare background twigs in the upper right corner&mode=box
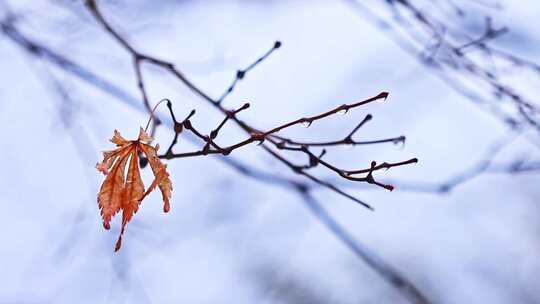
[346,0,540,131]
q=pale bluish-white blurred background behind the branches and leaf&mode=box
[0,0,540,303]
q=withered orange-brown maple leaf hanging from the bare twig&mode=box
[96,128,172,251]
